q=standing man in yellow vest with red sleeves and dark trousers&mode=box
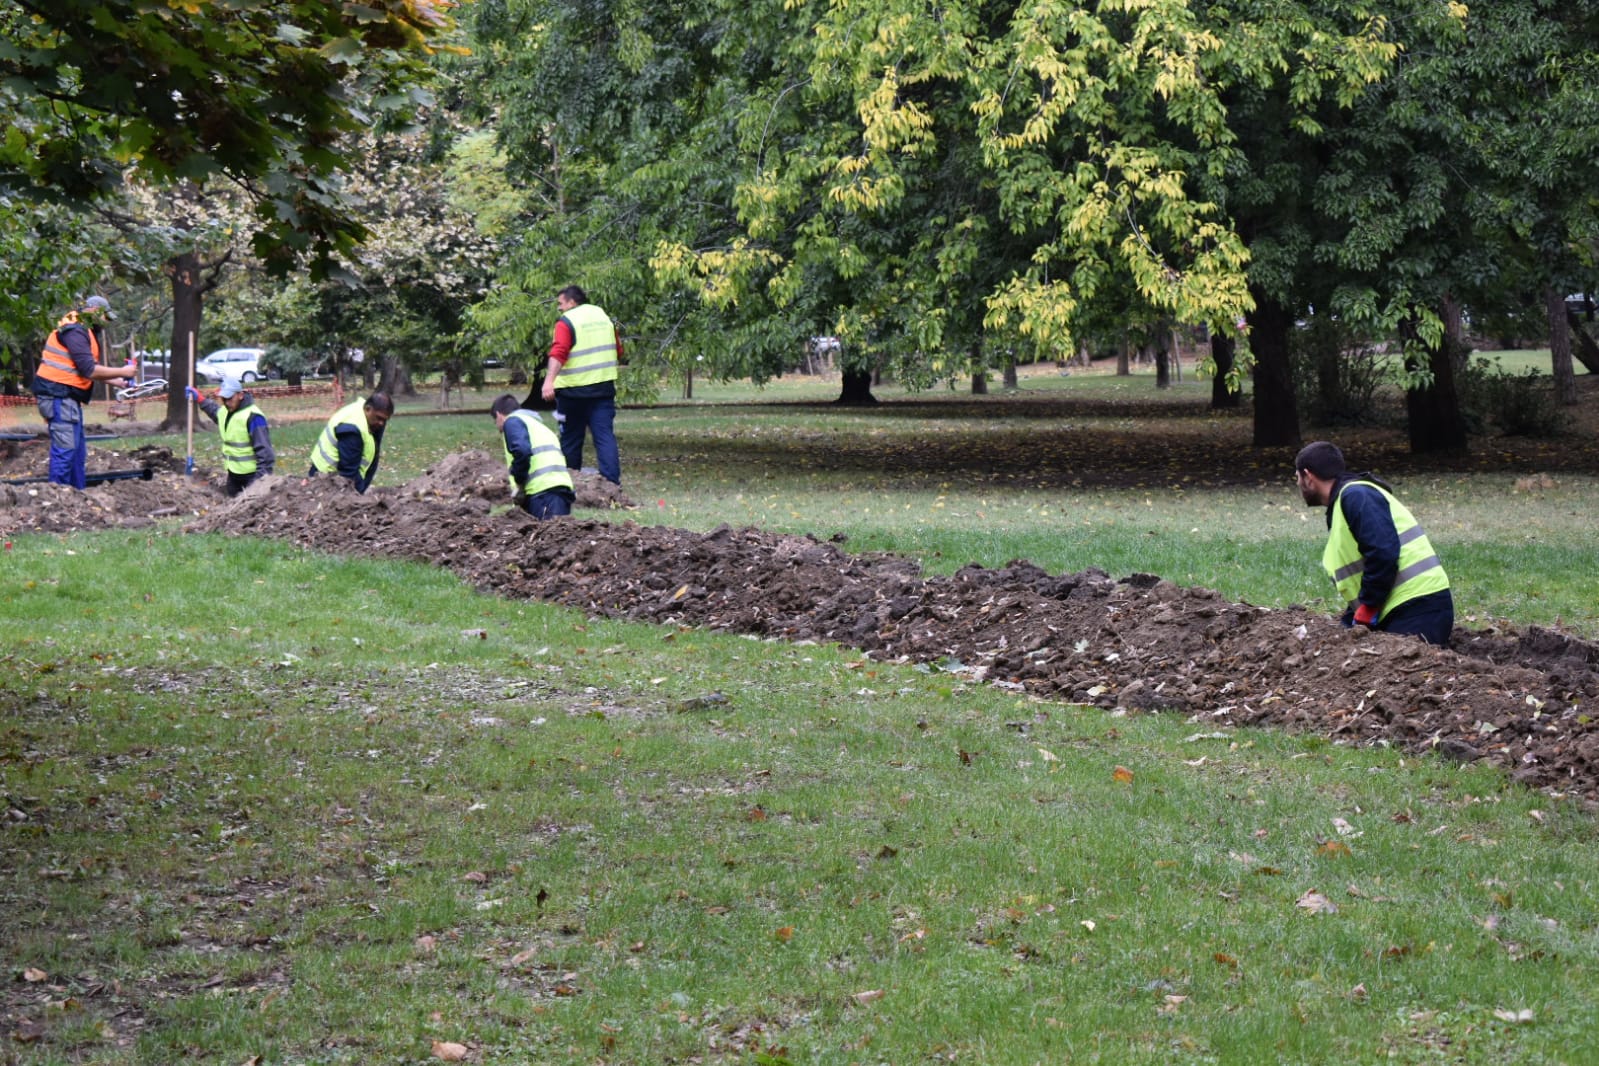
[542,284,622,484]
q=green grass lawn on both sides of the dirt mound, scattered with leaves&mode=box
[0,370,1599,1066]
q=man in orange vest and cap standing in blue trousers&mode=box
[34,296,138,489]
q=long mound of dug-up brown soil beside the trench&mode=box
[9,434,1599,801]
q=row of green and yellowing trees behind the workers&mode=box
[0,0,1599,451]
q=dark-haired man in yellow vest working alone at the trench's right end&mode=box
[1294,441,1455,647]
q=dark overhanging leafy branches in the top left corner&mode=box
[0,0,451,272]
